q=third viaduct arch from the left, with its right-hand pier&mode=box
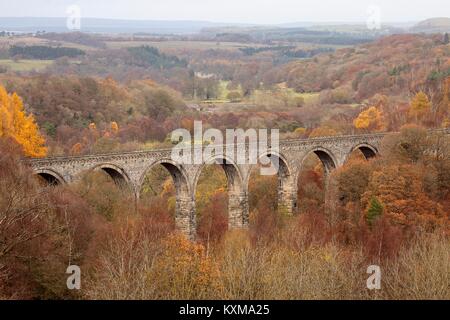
[136,159,196,239]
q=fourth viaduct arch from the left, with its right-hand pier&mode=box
[193,155,248,229]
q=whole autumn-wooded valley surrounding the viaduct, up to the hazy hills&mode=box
[0,26,450,299]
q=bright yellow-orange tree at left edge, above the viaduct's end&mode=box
[0,86,47,158]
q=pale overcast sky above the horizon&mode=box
[0,0,450,23]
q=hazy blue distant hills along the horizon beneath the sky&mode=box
[0,17,450,35]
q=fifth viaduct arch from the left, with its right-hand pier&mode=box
[253,150,297,215]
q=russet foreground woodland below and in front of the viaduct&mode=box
[0,126,450,299]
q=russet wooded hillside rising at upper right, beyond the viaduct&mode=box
[274,34,450,101]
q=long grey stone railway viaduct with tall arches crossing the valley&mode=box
[29,132,448,238]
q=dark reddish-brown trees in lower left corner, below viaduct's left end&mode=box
[0,138,93,299]
